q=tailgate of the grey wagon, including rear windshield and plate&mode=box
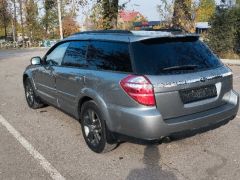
[133,38,232,119]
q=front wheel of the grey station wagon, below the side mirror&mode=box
[24,78,44,109]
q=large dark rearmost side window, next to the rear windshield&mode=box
[87,41,132,72]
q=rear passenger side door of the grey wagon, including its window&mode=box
[55,41,88,114]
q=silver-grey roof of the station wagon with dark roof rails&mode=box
[64,30,198,42]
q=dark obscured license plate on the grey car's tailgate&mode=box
[180,85,217,104]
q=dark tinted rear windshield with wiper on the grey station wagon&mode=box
[132,37,222,75]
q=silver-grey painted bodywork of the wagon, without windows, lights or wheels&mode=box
[24,31,239,139]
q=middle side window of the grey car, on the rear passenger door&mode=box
[62,41,87,67]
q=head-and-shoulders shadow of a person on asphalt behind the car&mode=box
[126,145,177,180]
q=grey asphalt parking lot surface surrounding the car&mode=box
[0,49,240,180]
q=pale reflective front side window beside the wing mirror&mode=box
[46,42,69,66]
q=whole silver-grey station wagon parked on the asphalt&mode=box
[23,31,239,153]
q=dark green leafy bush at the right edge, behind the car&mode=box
[208,7,240,58]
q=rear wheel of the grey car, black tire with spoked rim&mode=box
[81,100,117,153]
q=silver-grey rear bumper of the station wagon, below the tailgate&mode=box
[108,91,239,140]
